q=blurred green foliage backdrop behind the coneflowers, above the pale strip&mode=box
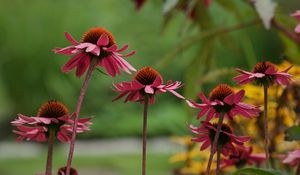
[0,0,299,139]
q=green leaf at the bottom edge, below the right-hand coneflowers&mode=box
[232,168,282,175]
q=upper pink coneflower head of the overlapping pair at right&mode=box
[187,84,260,121]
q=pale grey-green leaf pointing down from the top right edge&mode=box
[254,0,277,30]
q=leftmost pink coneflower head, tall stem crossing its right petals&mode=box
[11,101,91,142]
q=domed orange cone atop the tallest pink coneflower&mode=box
[81,27,116,46]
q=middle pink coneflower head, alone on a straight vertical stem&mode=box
[113,67,184,104]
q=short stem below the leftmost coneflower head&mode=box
[45,128,55,175]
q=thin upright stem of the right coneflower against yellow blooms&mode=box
[263,83,270,168]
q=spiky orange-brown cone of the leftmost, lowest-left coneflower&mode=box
[37,100,68,118]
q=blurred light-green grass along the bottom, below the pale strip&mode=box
[0,153,172,175]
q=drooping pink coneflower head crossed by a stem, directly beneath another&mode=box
[190,121,250,156]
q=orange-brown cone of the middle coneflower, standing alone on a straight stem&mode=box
[134,66,161,85]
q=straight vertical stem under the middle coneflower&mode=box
[142,95,149,175]
